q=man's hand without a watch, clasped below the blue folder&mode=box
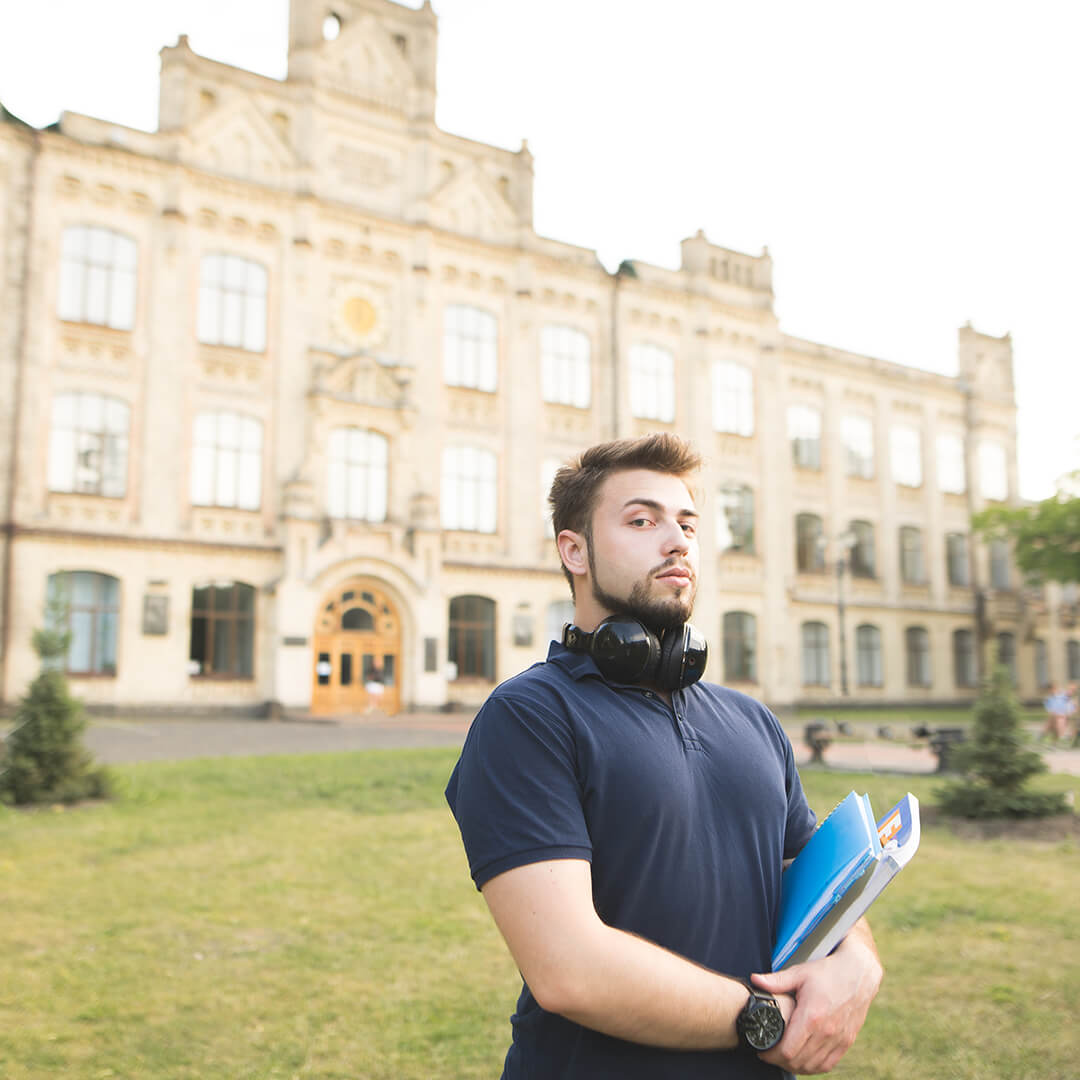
[751,919,882,1076]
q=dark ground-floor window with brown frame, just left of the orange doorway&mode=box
[188,581,255,678]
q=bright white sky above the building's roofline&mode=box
[0,0,1080,498]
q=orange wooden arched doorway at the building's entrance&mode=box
[311,578,402,715]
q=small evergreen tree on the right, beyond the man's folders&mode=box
[937,666,1066,818]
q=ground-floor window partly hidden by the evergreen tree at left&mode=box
[46,570,120,675]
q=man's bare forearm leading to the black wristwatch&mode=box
[482,859,768,1050]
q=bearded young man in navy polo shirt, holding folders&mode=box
[446,435,881,1080]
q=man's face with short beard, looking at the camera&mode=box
[589,469,700,631]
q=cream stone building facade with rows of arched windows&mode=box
[0,0,1080,713]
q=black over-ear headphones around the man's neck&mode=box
[563,615,708,690]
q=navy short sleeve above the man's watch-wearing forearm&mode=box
[446,696,592,889]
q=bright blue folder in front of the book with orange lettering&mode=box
[772,792,881,971]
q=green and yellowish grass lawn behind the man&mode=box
[0,750,1080,1080]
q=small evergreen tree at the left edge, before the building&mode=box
[0,610,109,804]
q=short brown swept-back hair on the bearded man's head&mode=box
[548,432,702,595]
